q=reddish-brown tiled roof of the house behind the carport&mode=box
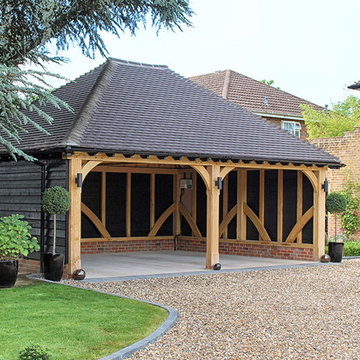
[190,70,324,118]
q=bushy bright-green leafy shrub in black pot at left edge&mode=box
[0,214,40,288]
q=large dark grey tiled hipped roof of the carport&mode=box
[7,59,341,167]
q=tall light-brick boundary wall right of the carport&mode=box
[309,127,360,239]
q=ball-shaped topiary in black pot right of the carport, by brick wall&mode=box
[326,192,346,262]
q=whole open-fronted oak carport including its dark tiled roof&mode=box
[0,58,343,276]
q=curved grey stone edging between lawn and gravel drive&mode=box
[26,274,179,360]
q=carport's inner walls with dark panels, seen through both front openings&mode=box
[81,163,315,268]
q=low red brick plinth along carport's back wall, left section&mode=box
[81,239,174,254]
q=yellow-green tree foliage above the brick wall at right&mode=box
[300,96,360,139]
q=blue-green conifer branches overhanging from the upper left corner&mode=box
[0,0,193,160]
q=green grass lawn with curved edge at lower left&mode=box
[0,283,168,360]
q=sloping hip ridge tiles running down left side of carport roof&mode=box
[61,59,113,146]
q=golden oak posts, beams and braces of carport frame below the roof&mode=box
[66,152,327,274]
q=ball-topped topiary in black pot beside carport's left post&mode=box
[42,186,70,281]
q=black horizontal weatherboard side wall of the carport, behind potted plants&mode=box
[0,159,68,258]
